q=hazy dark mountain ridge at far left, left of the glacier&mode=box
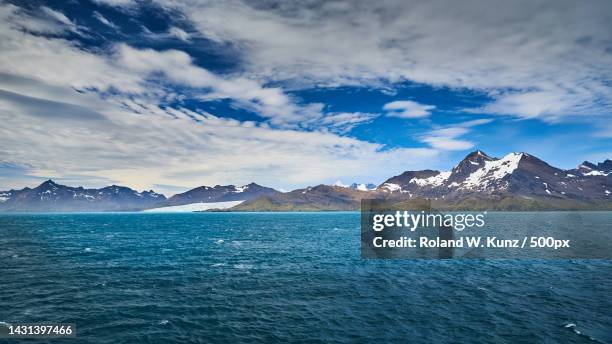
[0,180,166,212]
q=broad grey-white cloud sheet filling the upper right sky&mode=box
[154,0,612,117]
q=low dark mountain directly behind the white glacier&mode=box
[165,183,280,206]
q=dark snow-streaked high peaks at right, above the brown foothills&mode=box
[378,151,612,201]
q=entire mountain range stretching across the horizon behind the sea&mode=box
[0,150,612,212]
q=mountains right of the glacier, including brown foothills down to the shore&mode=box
[232,150,612,211]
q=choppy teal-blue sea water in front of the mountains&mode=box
[0,213,612,343]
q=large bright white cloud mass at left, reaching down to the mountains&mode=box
[0,2,438,191]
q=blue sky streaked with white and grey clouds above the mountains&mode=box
[0,0,612,195]
